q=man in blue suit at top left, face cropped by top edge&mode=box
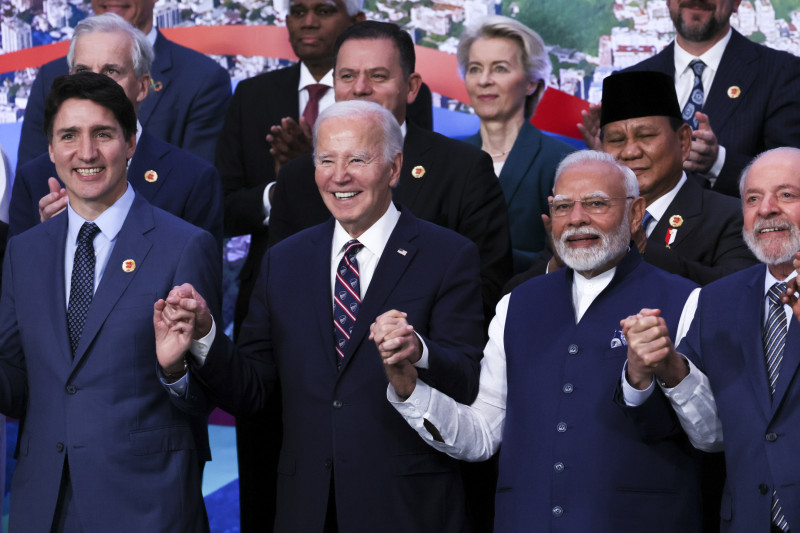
[17,0,231,168]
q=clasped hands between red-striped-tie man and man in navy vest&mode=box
[369,309,422,400]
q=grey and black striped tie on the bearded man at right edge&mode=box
[762,283,789,531]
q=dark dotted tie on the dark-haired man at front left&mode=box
[67,222,100,355]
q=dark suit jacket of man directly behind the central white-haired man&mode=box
[269,122,512,323]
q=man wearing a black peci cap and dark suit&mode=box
[600,72,756,285]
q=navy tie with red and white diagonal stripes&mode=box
[333,239,364,365]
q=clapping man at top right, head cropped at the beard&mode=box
[628,0,800,196]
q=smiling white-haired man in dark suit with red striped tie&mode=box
[154,98,483,533]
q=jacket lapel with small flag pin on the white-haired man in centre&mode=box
[336,211,418,373]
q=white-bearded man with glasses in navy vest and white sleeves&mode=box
[379,151,701,533]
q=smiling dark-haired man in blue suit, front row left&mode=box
[0,73,221,533]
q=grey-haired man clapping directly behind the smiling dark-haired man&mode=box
[9,14,222,246]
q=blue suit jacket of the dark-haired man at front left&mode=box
[0,195,221,533]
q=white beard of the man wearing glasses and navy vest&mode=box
[553,213,631,272]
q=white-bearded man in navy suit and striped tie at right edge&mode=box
[623,148,800,533]
